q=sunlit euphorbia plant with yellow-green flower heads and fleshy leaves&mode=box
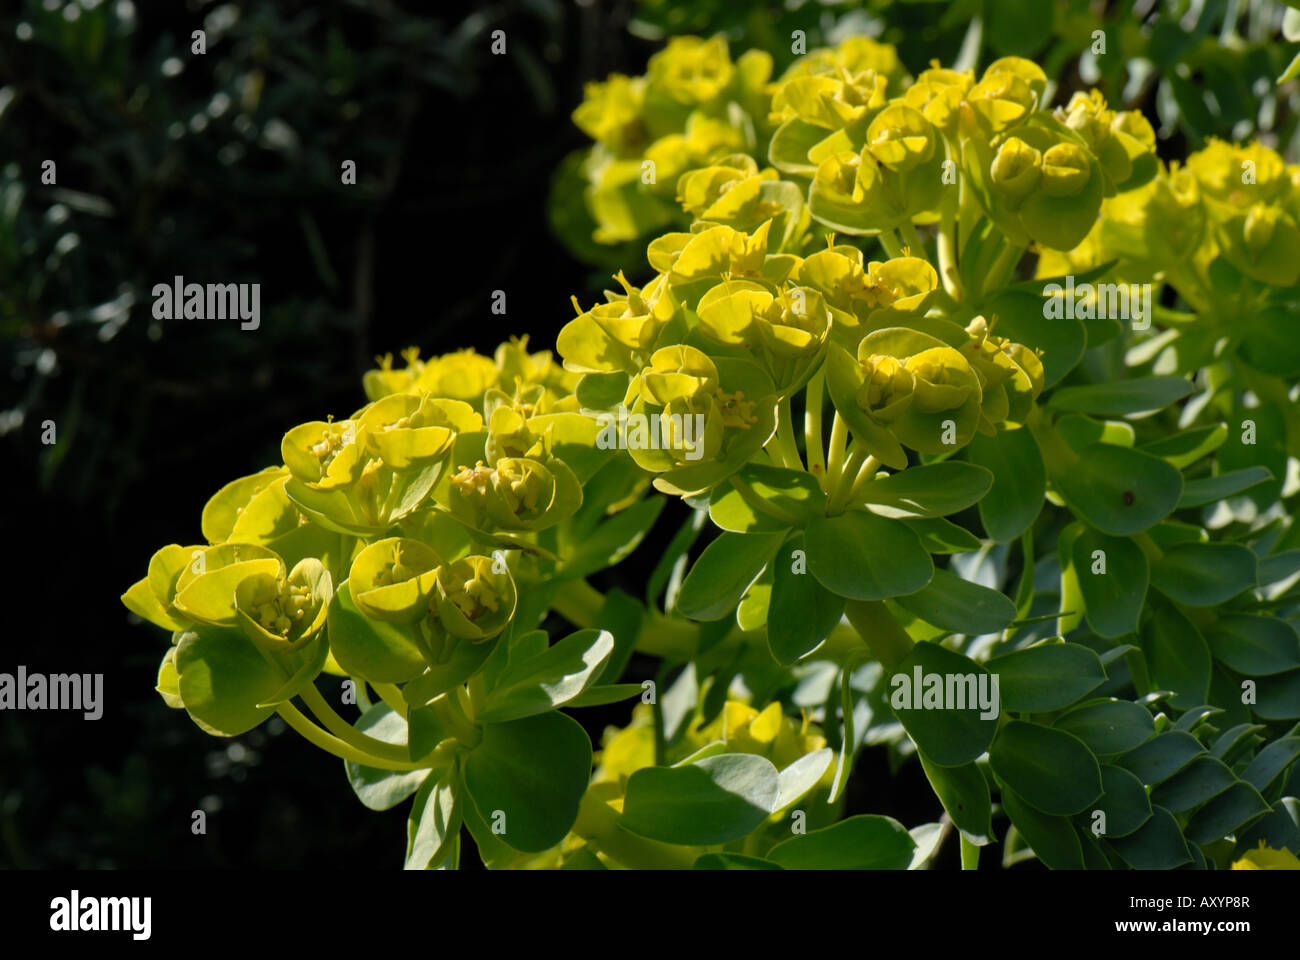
[124,40,1300,869]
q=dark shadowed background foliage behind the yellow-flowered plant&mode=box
[0,0,1291,868]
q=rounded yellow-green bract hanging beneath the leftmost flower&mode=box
[174,629,283,736]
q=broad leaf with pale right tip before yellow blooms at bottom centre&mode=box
[619,753,780,846]
